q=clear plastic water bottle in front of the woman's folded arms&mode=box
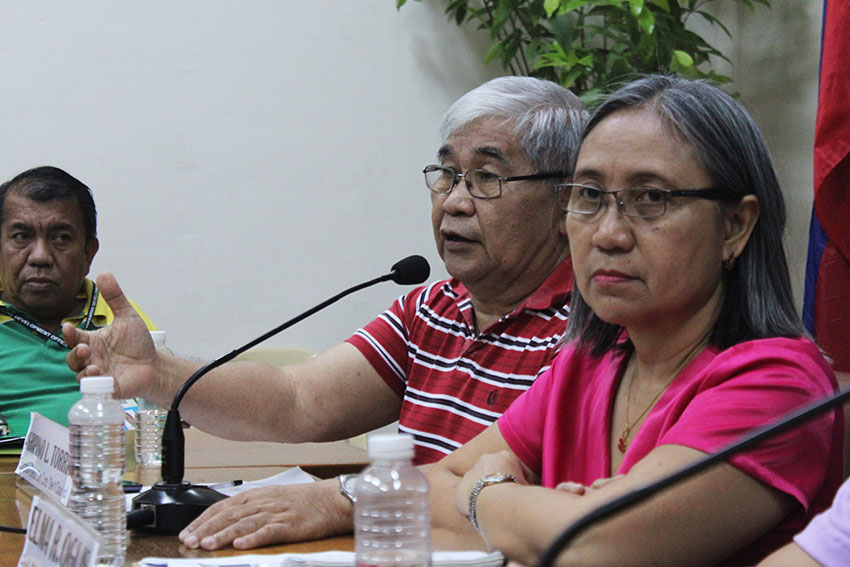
[354,433,431,567]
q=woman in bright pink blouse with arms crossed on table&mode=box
[430,76,843,565]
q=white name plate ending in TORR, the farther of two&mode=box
[15,412,71,505]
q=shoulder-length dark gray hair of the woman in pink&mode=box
[566,76,805,354]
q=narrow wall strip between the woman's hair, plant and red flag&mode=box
[716,0,823,312]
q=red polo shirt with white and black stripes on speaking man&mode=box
[348,259,573,464]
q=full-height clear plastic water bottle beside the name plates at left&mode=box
[68,376,127,567]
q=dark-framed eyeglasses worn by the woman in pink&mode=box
[555,183,723,219]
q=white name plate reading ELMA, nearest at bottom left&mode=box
[18,495,100,567]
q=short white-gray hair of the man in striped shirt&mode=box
[440,77,588,172]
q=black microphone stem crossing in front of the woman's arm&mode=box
[537,387,850,567]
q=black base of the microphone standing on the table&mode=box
[133,482,227,535]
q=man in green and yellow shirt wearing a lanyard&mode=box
[0,167,155,436]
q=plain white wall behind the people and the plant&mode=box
[0,0,820,358]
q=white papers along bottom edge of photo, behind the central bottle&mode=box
[140,551,505,567]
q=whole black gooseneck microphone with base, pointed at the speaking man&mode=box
[130,256,431,535]
